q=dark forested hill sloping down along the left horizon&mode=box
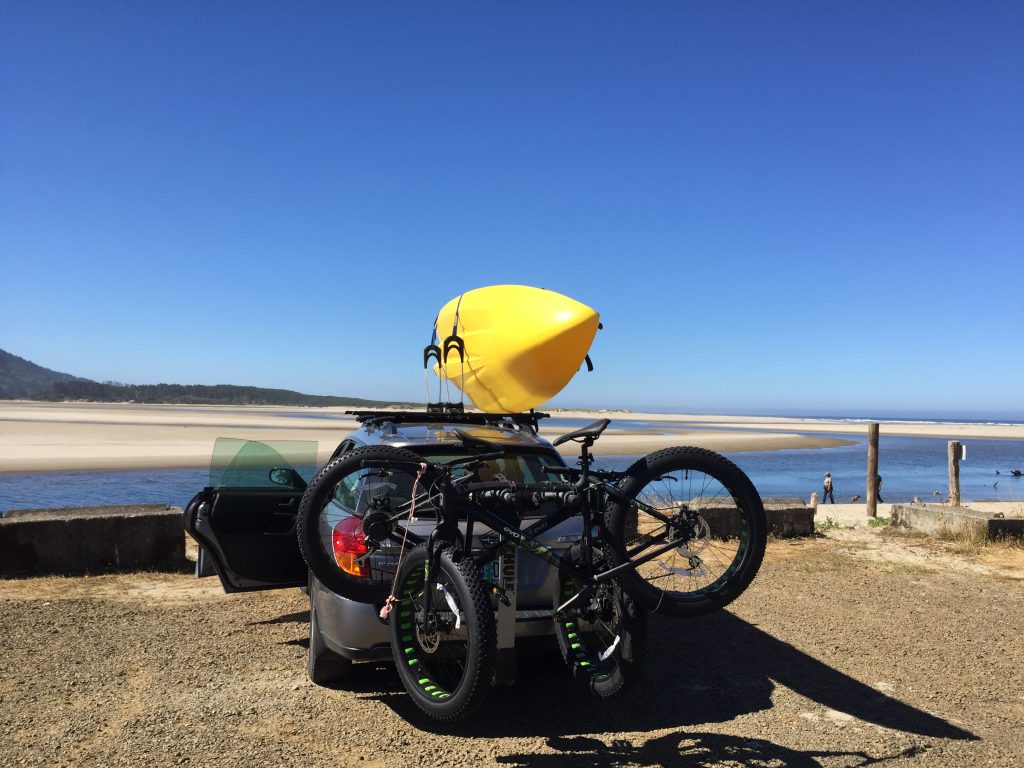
[0,349,412,408]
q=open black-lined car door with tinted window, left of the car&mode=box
[183,437,316,592]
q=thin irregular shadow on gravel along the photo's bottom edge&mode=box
[497,733,921,768]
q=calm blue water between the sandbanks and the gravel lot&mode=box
[0,419,1024,511]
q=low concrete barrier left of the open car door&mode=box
[0,504,185,578]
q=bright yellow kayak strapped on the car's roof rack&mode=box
[434,286,600,414]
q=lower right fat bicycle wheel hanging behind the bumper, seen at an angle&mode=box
[555,548,647,698]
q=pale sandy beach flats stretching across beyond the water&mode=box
[0,400,1024,472]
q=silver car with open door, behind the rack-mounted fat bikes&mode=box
[184,411,580,684]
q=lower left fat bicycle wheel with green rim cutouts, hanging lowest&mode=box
[390,545,497,721]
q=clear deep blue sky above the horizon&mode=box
[0,0,1024,416]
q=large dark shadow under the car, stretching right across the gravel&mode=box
[375,611,977,741]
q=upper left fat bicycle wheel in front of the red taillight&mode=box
[296,445,436,603]
